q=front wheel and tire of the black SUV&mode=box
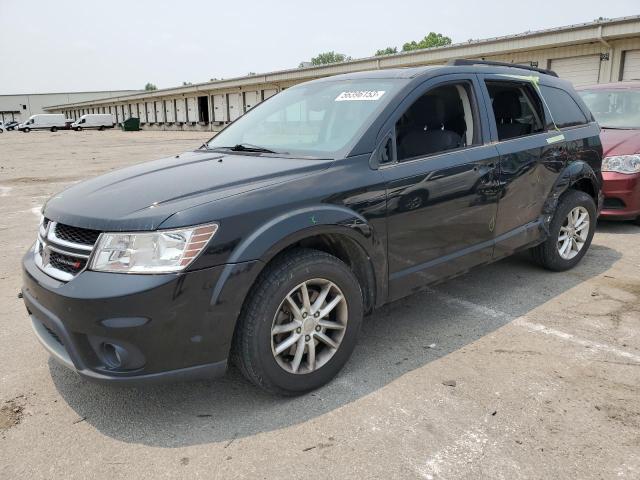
[232,249,363,396]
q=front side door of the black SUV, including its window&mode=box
[380,74,498,299]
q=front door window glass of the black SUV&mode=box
[396,82,479,162]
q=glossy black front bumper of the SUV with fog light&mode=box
[22,250,259,384]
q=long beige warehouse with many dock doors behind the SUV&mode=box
[45,15,640,131]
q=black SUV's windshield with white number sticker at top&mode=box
[207,79,404,158]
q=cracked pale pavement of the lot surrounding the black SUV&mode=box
[0,131,640,480]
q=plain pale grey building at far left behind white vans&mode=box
[0,90,139,123]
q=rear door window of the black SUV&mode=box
[486,82,544,141]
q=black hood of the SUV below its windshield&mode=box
[44,152,332,231]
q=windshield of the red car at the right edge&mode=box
[578,89,640,129]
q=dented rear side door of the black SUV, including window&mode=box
[479,74,566,258]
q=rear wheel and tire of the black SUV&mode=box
[531,190,597,272]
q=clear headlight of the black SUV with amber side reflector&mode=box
[90,224,218,273]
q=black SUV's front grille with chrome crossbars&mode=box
[34,218,100,282]
